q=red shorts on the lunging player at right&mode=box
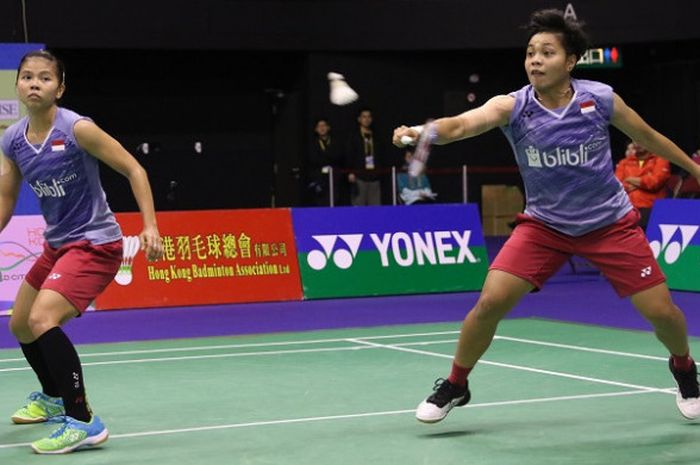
[490,210,666,297]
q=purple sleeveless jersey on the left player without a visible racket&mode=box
[2,108,122,247]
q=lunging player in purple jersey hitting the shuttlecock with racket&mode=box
[393,10,700,423]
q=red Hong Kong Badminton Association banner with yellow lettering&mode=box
[95,209,302,310]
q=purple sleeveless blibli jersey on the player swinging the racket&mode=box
[501,79,632,236]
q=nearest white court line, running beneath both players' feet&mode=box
[0,391,651,449]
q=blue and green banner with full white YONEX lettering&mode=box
[292,204,488,299]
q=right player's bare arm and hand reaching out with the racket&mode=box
[393,95,515,147]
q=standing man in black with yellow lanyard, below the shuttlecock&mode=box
[345,108,382,206]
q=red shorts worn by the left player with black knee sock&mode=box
[24,239,122,313]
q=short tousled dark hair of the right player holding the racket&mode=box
[526,9,590,60]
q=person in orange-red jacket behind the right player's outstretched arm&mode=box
[615,142,671,230]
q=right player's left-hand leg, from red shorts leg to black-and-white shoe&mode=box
[416,217,569,423]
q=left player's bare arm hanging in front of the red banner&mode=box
[74,120,163,260]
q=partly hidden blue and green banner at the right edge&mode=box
[647,199,700,291]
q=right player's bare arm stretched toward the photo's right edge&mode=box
[611,94,700,180]
